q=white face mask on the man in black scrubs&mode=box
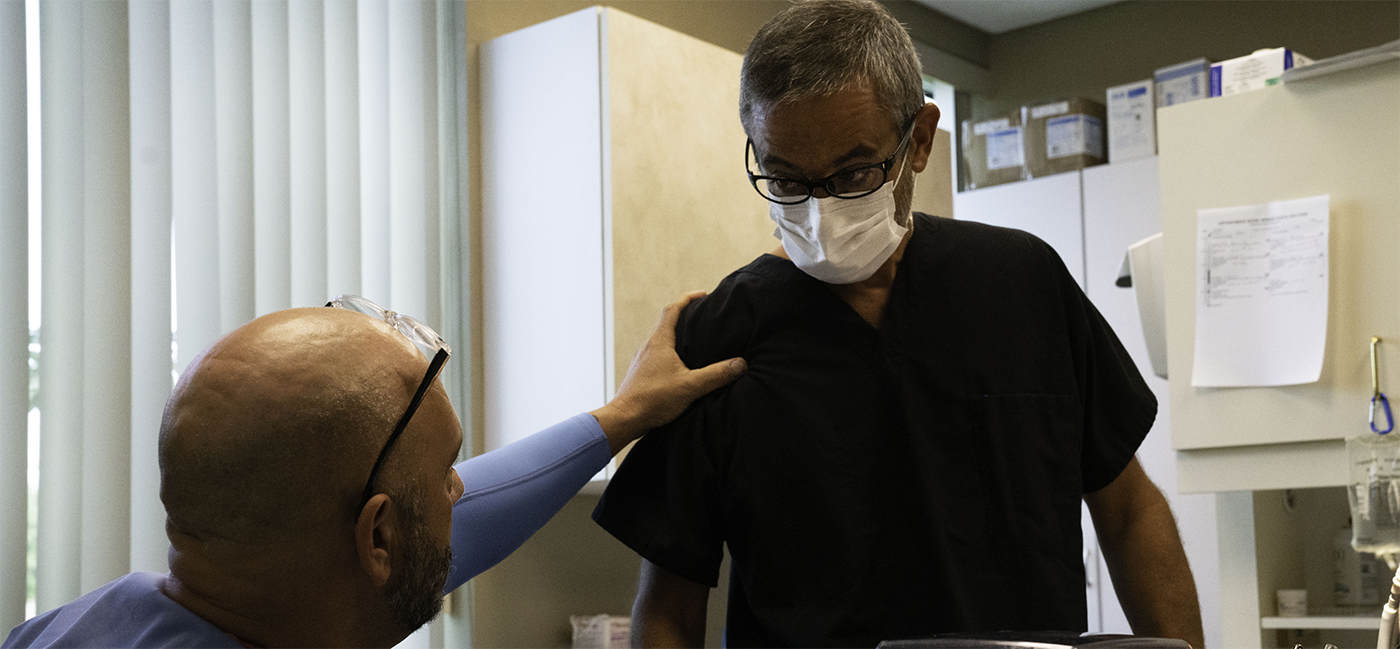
[769,157,909,284]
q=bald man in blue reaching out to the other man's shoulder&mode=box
[3,294,743,649]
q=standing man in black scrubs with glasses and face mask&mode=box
[594,0,1201,649]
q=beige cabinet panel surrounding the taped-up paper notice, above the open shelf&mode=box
[1159,63,1400,475]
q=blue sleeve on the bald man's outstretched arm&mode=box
[444,413,612,592]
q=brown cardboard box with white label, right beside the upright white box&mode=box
[1023,98,1107,178]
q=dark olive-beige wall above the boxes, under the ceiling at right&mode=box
[973,0,1400,117]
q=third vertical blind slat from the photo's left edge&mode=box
[77,1,132,592]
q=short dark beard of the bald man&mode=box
[388,494,452,634]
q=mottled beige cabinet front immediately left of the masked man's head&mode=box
[605,8,778,391]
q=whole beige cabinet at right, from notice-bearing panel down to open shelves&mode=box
[1158,62,1400,648]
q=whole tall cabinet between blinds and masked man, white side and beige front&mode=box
[480,7,776,461]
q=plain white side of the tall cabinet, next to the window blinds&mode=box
[480,10,606,449]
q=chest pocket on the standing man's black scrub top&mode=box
[967,394,1084,554]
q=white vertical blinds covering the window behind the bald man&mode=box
[0,0,470,629]
